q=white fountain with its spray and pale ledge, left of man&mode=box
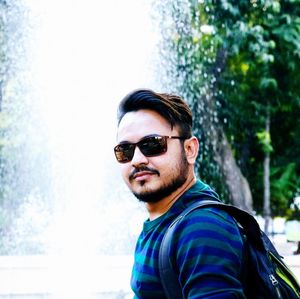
[0,0,156,299]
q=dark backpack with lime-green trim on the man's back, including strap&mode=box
[159,200,300,299]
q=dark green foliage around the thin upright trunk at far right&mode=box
[209,1,300,215]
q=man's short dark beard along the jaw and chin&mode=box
[132,153,189,203]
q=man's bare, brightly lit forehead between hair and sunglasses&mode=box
[117,109,175,142]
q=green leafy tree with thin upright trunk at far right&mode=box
[214,1,300,232]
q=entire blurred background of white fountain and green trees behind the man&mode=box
[0,0,300,299]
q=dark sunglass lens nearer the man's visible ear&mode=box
[138,136,167,157]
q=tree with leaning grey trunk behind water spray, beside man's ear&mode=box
[152,1,252,211]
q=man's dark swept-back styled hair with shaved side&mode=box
[118,89,193,138]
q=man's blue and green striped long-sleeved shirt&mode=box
[131,180,246,299]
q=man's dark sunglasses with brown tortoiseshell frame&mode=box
[114,135,187,163]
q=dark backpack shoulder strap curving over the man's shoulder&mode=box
[158,200,265,299]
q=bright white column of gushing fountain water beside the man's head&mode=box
[27,0,154,253]
